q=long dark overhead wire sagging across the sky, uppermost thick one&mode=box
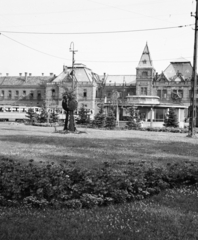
[0,24,194,35]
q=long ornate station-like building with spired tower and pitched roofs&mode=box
[0,44,193,127]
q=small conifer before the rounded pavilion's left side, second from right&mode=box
[126,106,141,129]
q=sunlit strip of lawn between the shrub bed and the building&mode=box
[0,123,198,168]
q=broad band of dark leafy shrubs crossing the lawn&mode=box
[0,159,198,208]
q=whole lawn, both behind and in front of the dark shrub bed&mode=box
[0,123,198,240]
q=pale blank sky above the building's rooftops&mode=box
[0,0,196,75]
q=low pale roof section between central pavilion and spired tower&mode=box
[106,75,136,85]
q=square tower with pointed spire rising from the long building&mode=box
[136,43,155,95]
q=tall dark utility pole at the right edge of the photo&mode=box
[188,0,198,137]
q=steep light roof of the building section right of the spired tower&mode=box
[163,59,193,81]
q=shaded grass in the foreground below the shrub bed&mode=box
[0,188,198,240]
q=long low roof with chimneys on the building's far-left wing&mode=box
[0,76,54,86]
